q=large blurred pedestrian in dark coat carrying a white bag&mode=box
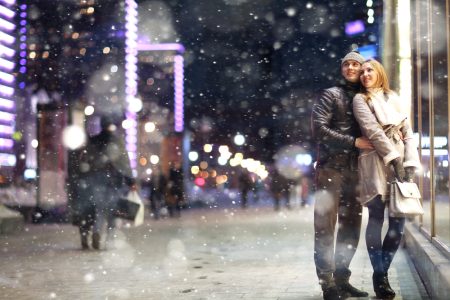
[80,116,136,249]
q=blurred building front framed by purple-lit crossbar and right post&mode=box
[137,43,186,178]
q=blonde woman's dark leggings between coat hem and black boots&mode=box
[366,196,405,273]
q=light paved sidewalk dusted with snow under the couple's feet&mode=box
[0,203,429,300]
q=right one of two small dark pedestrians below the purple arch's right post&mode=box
[165,163,184,218]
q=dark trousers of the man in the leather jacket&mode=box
[314,168,362,288]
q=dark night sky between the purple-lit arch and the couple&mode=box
[158,0,376,160]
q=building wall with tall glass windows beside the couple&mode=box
[383,0,450,299]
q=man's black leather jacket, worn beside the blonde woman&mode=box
[311,84,361,170]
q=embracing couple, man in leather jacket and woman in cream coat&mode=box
[312,51,420,300]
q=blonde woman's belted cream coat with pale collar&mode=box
[353,90,420,204]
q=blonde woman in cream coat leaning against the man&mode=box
[353,60,420,299]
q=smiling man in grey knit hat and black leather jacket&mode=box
[312,51,372,300]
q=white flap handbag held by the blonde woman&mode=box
[389,181,424,217]
